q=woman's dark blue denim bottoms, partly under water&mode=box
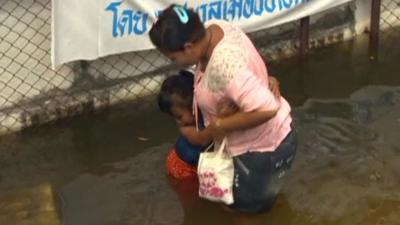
[230,129,297,212]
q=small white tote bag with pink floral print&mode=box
[197,137,234,205]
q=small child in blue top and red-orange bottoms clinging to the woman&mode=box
[158,70,238,179]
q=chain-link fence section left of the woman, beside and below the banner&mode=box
[0,0,173,134]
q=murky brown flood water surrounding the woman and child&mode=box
[0,33,400,225]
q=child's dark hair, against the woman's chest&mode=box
[158,70,194,115]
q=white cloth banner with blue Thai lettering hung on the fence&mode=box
[51,0,351,67]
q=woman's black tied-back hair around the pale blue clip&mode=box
[149,4,206,52]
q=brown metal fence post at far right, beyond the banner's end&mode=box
[368,0,381,60]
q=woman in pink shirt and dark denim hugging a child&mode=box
[150,5,297,212]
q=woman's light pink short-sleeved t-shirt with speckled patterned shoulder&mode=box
[194,20,292,156]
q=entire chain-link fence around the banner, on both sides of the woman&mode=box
[0,0,392,134]
